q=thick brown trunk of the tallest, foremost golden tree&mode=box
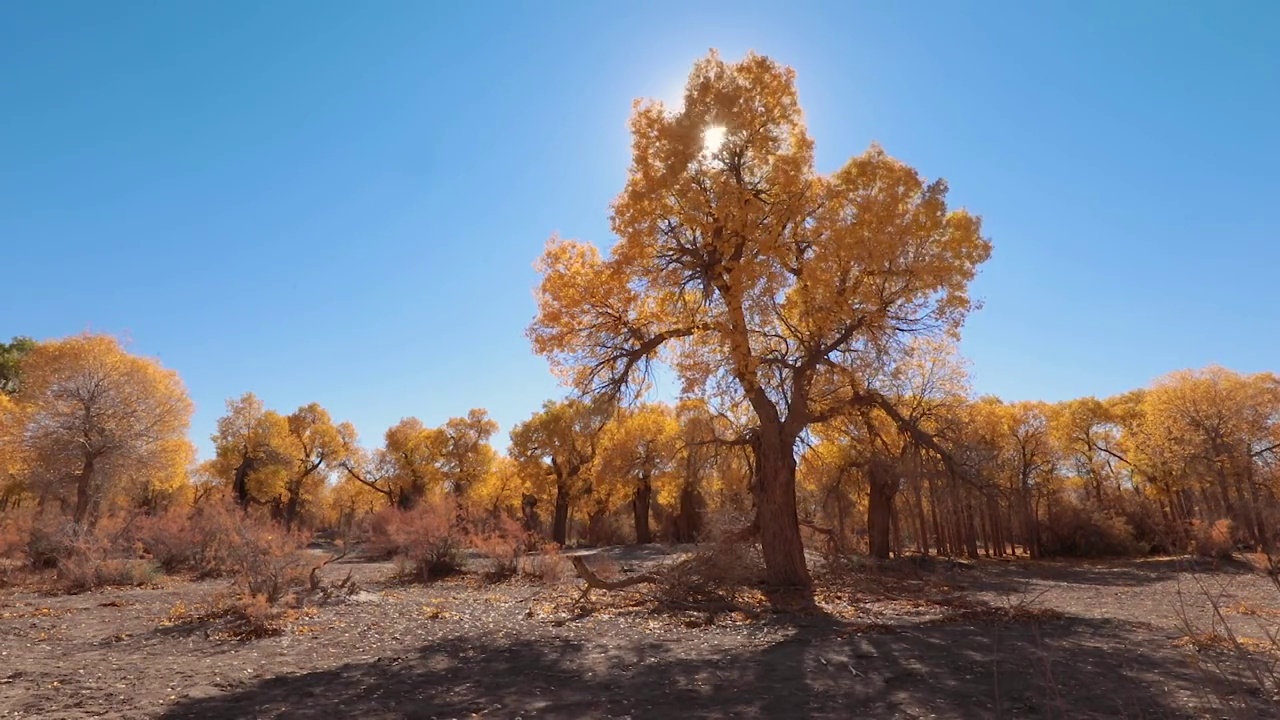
[754,428,813,589]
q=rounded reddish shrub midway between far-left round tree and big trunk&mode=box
[366,498,466,582]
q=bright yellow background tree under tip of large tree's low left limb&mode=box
[593,402,680,544]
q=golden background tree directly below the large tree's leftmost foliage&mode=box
[509,398,613,544]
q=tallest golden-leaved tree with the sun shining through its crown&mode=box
[529,53,991,587]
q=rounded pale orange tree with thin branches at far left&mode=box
[18,334,195,525]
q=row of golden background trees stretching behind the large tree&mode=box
[0,334,1280,576]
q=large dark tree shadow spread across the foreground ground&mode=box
[157,609,1274,719]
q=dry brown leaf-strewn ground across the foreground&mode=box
[0,548,1280,720]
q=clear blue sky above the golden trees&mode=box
[0,0,1280,454]
